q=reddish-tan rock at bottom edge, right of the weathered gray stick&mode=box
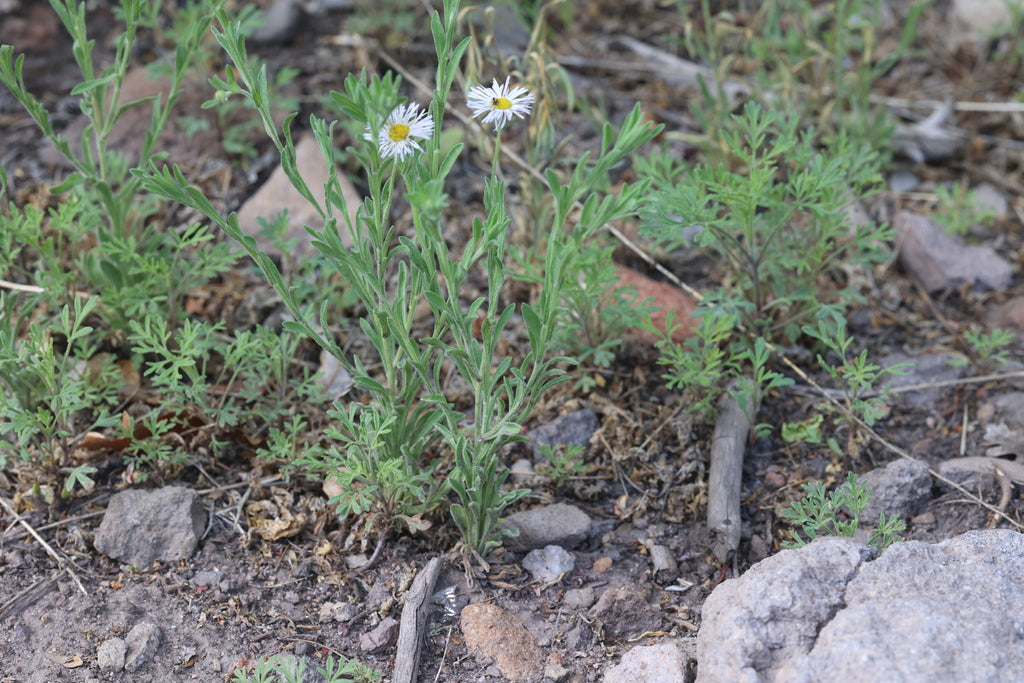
[460,602,545,681]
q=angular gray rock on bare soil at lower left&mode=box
[95,486,207,568]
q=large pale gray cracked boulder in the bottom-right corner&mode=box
[697,529,1024,683]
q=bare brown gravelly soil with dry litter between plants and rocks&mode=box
[0,1,1024,683]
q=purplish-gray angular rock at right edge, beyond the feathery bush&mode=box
[893,211,1014,292]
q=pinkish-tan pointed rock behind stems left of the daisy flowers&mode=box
[239,135,362,259]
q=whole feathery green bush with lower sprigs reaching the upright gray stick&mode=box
[638,102,892,428]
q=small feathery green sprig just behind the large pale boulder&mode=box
[781,472,906,551]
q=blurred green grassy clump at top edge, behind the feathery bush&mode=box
[677,0,930,151]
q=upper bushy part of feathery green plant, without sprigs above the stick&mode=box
[639,102,892,342]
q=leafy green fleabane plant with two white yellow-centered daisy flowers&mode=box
[136,0,657,562]
